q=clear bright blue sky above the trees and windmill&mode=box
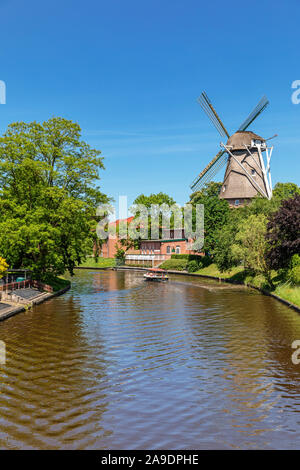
[0,0,300,204]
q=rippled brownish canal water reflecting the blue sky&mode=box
[0,271,300,449]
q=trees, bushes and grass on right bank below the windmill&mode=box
[161,183,300,306]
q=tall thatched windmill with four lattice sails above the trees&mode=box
[191,92,276,206]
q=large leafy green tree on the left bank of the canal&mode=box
[0,118,108,278]
